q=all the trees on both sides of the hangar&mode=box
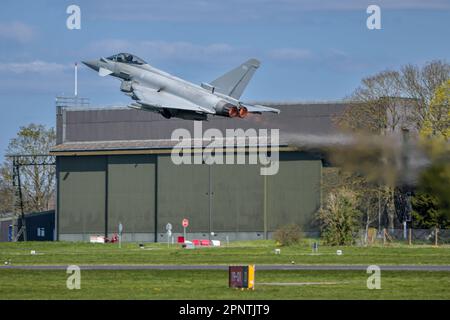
[0,61,450,243]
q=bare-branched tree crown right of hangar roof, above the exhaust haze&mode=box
[337,60,450,134]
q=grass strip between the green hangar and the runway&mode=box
[0,240,450,265]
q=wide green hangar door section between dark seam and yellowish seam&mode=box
[158,155,264,241]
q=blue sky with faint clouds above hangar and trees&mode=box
[0,0,450,156]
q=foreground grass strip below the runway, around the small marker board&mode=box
[0,270,450,299]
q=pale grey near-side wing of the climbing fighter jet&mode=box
[133,85,215,114]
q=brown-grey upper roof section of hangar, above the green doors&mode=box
[51,102,348,155]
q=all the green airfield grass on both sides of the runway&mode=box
[0,240,450,299]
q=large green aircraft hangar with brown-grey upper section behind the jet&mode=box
[51,102,345,242]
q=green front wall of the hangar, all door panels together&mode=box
[58,152,322,240]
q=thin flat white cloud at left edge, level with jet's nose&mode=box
[0,60,70,74]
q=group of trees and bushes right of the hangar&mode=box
[317,61,450,244]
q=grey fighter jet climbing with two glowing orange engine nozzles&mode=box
[83,53,280,120]
